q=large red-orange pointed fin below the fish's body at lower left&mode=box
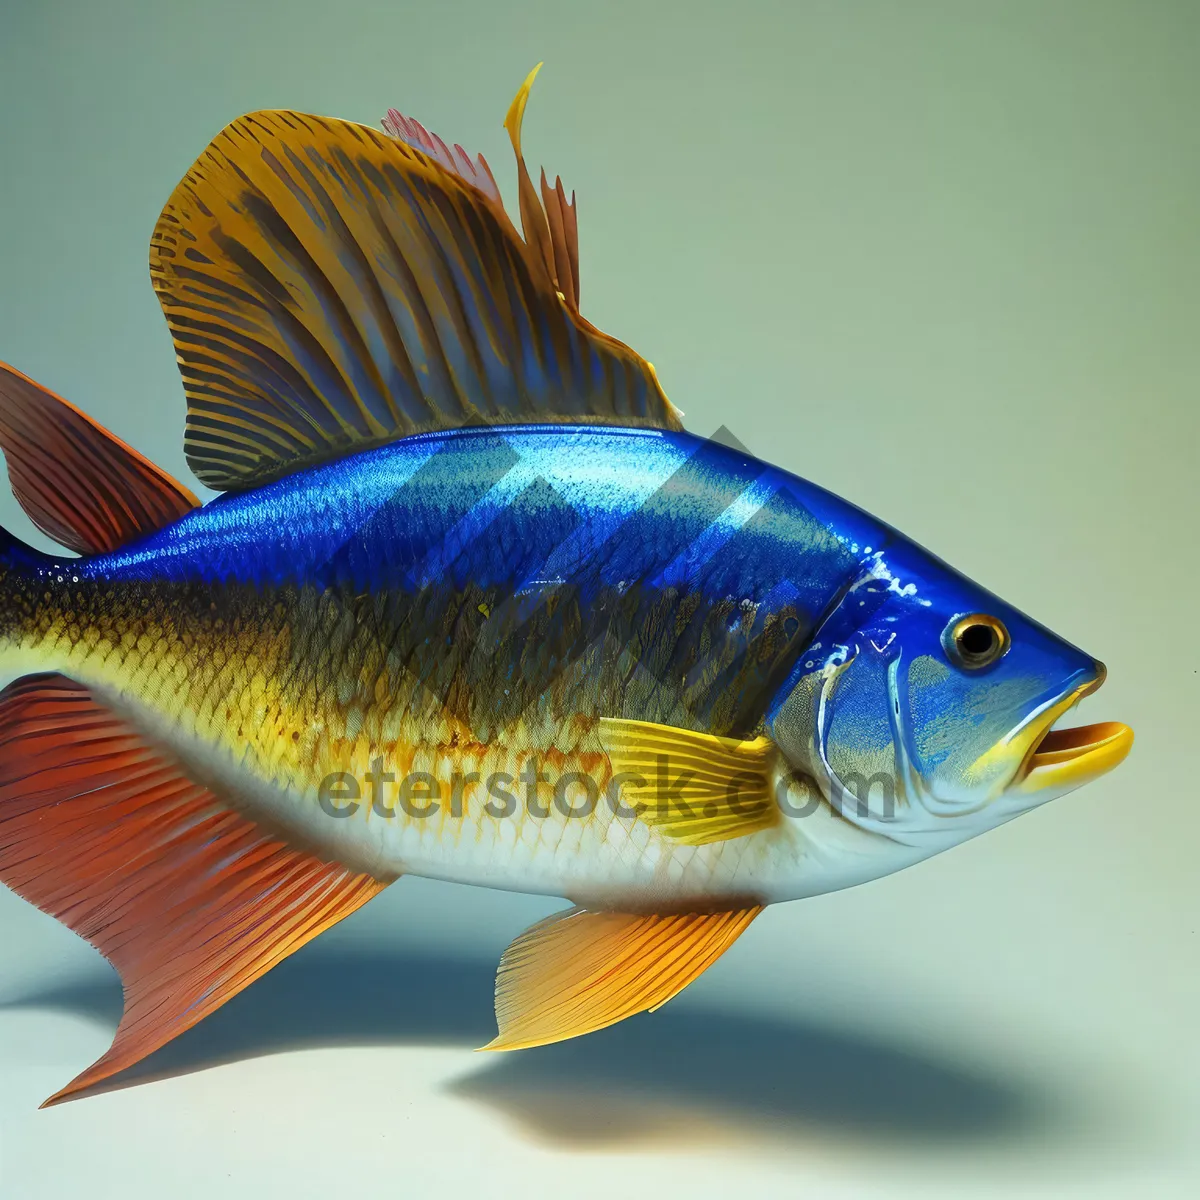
[0,674,390,1104]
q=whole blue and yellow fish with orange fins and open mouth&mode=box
[0,68,1133,1104]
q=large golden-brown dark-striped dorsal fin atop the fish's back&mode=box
[150,77,680,488]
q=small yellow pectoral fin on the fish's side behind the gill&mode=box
[600,718,780,846]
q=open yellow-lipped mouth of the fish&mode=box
[1016,662,1133,793]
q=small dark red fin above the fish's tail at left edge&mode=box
[0,362,199,554]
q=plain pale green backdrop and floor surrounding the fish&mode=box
[0,0,1200,1200]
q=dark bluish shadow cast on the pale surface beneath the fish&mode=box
[4,947,1072,1146]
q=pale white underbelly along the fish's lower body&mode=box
[98,676,922,908]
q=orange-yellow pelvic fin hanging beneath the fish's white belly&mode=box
[482,906,762,1050]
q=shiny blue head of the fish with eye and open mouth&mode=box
[768,539,1133,853]
